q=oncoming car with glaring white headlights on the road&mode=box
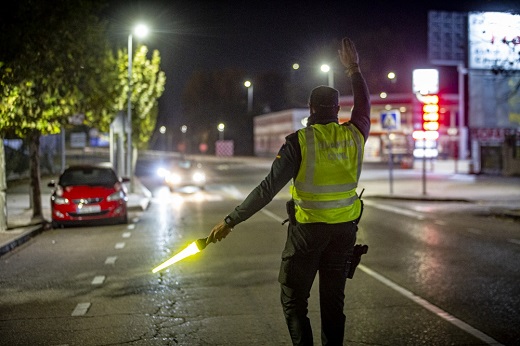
[157,161,206,191]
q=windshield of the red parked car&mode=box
[59,167,119,186]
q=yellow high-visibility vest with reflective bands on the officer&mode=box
[291,123,365,224]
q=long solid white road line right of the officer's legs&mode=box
[358,264,502,345]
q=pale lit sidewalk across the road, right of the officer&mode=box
[358,160,520,220]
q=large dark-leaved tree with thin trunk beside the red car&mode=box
[0,0,116,219]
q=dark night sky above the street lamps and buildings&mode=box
[107,0,520,141]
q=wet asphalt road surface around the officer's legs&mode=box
[0,160,520,345]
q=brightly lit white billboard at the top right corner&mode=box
[468,12,520,70]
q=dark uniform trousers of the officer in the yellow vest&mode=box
[278,222,357,346]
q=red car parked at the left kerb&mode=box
[48,165,129,227]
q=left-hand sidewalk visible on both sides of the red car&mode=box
[0,179,152,256]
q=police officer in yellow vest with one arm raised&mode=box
[207,38,370,345]
